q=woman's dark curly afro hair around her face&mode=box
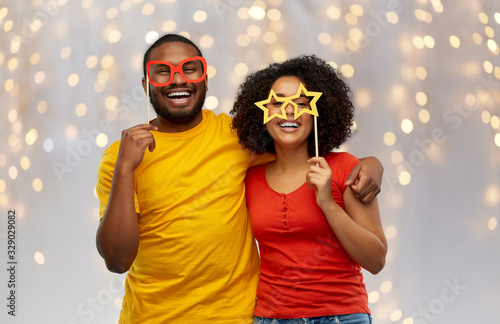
[230,55,354,156]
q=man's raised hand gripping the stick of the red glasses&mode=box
[116,124,158,171]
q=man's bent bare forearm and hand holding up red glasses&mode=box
[96,125,157,273]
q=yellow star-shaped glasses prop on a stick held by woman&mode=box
[254,83,323,156]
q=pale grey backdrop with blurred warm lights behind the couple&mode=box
[0,0,500,324]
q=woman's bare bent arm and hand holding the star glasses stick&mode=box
[307,157,387,274]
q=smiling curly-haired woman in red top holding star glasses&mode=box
[231,56,387,323]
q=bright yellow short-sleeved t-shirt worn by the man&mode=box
[97,110,269,324]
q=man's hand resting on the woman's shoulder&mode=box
[345,156,384,203]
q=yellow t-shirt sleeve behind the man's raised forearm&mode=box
[96,143,140,220]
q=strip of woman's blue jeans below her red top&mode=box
[253,313,372,324]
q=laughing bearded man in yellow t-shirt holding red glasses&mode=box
[96,35,382,324]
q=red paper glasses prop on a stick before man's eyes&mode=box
[146,56,207,124]
